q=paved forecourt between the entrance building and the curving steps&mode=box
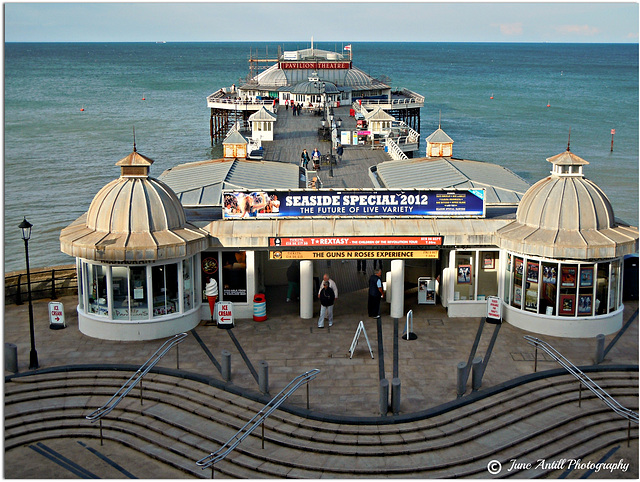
[4,287,638,416]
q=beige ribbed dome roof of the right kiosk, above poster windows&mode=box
[497,148,638,259]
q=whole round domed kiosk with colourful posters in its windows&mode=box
[496,147,638,338]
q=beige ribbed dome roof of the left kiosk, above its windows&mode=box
[60,146,207,263]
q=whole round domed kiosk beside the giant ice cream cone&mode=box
[60,144,208,340]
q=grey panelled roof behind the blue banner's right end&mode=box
[372,157,530,204]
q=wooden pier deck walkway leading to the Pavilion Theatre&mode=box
[262,105,391,189]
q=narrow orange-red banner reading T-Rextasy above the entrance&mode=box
[269,236,442,248]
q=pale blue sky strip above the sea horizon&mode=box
[4,0,639,43]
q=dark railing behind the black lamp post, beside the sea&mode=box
[4,265,78,305]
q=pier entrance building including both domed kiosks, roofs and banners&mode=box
[60,141,638,340]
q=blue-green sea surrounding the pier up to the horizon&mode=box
[4,42,639,272]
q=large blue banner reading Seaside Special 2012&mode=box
[223,189,485,219]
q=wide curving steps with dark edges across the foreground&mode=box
[4,367,638,479]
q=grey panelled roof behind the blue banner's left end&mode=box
[159,159,300,207]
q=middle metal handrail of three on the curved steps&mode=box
[196,368,320,469]
